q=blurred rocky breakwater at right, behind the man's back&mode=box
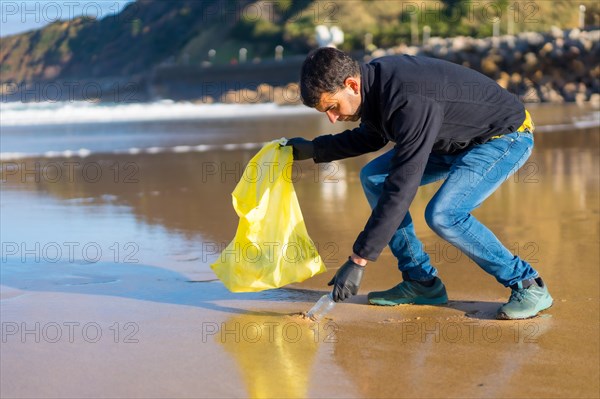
[366,28,600,106]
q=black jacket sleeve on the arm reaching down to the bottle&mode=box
[353,96,443,261]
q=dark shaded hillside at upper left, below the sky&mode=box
[0,0,247,82]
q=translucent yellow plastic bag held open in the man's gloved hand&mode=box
[210,139,326,292]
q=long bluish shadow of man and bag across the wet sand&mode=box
[0,262,501,320]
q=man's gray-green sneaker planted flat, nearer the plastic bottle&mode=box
[368,277,448,306]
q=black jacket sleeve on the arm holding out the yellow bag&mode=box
[313,123,388,163]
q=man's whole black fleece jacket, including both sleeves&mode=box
[313,55,525,261]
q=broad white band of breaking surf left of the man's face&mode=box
[0,100,315,127]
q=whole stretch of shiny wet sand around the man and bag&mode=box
[0,107,600,398]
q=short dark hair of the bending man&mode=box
[300,47,360,108]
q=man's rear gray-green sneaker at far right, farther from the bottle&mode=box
[496,277,552,320]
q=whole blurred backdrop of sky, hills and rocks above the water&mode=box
[0,0,600,103]
